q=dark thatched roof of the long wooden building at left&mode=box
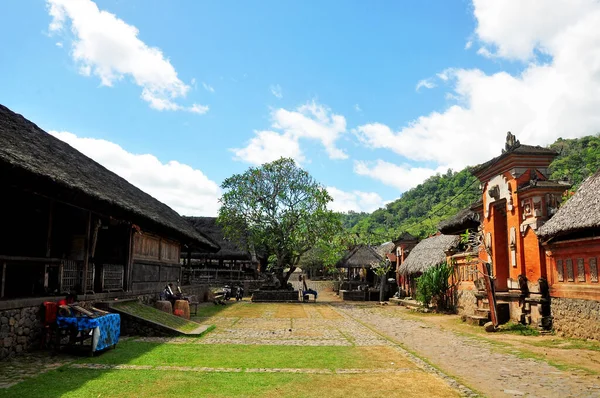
[0,105,219,251]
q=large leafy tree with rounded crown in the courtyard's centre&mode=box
[218,158,342,286]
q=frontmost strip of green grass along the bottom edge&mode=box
[0,368,459,398]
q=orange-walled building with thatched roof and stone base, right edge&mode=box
[538,170,600,340]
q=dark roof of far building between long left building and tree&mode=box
[186,217,252,261]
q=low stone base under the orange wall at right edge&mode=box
[550,297,600,340]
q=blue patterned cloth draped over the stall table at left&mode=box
[56,314,121,352]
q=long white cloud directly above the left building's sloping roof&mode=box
[50,131,221,216]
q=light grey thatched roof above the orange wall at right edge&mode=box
[537,170,600,239]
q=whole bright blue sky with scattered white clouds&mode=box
[0,0,600,215]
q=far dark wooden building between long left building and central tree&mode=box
[181,217,266,283]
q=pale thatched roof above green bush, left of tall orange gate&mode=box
[400,235,460,275]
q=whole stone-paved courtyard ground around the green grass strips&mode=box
[0,294,600,397]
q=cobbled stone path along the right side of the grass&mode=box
[337,304,600,397]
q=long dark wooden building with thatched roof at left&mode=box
[0,105,219,300]
